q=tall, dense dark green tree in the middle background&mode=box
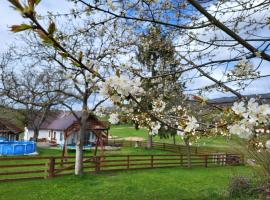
[137,26,183,148]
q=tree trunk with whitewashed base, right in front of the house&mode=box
[75,105,88,175]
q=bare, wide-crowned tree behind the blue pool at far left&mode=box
[0,52,65,141]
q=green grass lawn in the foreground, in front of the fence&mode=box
[0,167,254,200]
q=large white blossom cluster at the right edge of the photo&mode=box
[228,98,270,139]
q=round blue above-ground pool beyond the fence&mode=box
[0,141,36,155]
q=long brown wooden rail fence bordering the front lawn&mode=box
[0,154,244,182]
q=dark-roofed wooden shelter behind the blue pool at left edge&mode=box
[0,118,23,140]
